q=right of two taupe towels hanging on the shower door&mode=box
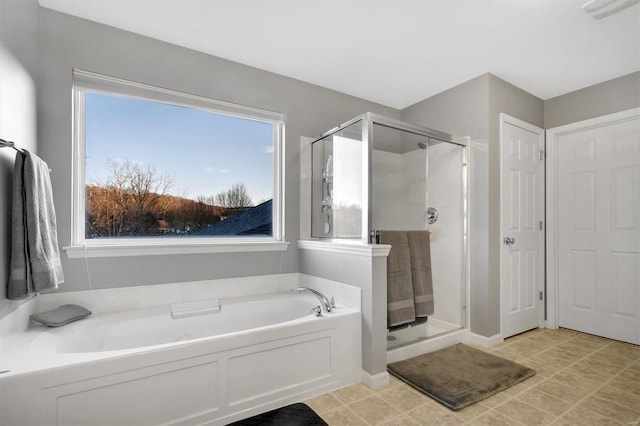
[407,231,433,318]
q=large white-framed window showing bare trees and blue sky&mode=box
[65,70,286,257]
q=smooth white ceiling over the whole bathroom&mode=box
[39,0,640,109]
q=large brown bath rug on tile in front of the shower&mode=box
[387,343,536,411]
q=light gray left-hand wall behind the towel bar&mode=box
[0,0,38,318]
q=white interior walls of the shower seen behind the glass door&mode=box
[371,126,466,327]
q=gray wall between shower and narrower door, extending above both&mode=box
[402,74,543,336]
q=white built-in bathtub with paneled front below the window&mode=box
[0,292,361,426]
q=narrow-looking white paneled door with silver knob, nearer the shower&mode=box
[500,114,544,337]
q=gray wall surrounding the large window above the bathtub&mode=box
[0,4,400,316]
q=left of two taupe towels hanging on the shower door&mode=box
[380,231,416,327]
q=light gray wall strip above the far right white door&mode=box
[544,71,640,129]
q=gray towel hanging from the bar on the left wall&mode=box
[7,151,64,299]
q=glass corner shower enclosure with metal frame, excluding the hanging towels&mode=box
[311,112,468,349]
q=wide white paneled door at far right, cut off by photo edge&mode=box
[555,111,640,344]
